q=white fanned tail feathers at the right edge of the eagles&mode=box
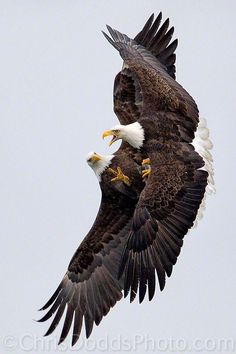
[192,118,215,227]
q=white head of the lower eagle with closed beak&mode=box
[86,151,114,182]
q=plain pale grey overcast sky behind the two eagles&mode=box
[0,0,236,354]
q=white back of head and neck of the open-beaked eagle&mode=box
[122,122,144,149]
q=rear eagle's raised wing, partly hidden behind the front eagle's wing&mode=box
[113,12,178,125]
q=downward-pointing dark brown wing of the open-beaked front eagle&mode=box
[120,144,208,302]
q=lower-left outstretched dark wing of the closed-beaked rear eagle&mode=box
[39,194,135,345]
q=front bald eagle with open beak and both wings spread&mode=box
[103,21,215,302]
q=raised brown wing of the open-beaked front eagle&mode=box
[104,26,199,142]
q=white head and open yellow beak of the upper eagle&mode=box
[102,122,144,149]
